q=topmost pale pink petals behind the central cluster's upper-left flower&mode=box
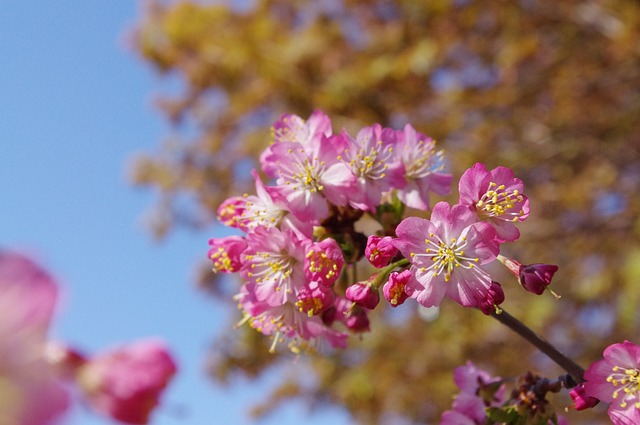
[260,111,331,177]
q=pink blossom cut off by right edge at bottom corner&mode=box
[584,341,640,425]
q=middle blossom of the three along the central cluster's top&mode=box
[341,124,406,212]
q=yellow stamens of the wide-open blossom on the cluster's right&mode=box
[415,233,479,282]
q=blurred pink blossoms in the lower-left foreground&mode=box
[0,251,176,425]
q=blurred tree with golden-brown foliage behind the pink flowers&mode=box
[133,0,640,423]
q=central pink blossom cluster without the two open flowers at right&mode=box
[208,111,452,351]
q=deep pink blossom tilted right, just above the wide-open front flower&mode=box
[459,163,529,242]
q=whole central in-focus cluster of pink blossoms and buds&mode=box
[208,111,555,350]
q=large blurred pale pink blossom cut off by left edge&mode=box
[0,251,69,425]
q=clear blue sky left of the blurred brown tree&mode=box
[0,0,349,425]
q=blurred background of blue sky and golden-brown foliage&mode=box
[0,0,640,424]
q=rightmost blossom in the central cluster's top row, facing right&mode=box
[396,124,453,210]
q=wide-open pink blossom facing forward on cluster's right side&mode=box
[394,202,499,307]
